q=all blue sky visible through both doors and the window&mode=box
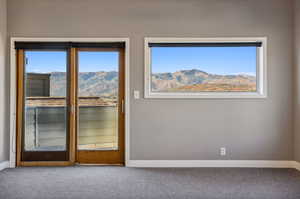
[26,47,256,75]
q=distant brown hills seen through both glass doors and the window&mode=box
[50,69,256,97]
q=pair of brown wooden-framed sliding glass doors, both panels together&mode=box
[16,42,125,166]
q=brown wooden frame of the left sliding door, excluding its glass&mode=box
[16,49,75,166]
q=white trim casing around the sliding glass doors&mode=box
[10,37,130,168]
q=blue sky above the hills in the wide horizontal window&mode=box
[151,47,256,75]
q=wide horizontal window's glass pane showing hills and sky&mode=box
[150,46,257,92]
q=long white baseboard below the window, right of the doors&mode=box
[126,160,300,168]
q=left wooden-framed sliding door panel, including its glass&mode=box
[16,48,72,166]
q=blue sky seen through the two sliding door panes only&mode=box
[25,51,118,73]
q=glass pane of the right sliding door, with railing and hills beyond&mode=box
[78,51,119,150]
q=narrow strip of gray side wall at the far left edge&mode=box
[0,0,9,162]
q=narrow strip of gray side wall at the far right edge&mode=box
[294,0,300,162]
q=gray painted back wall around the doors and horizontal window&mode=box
[5,0,293,160]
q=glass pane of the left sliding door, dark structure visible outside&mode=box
[24,51,67,151]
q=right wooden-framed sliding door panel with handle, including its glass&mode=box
[76,48,125,164]
